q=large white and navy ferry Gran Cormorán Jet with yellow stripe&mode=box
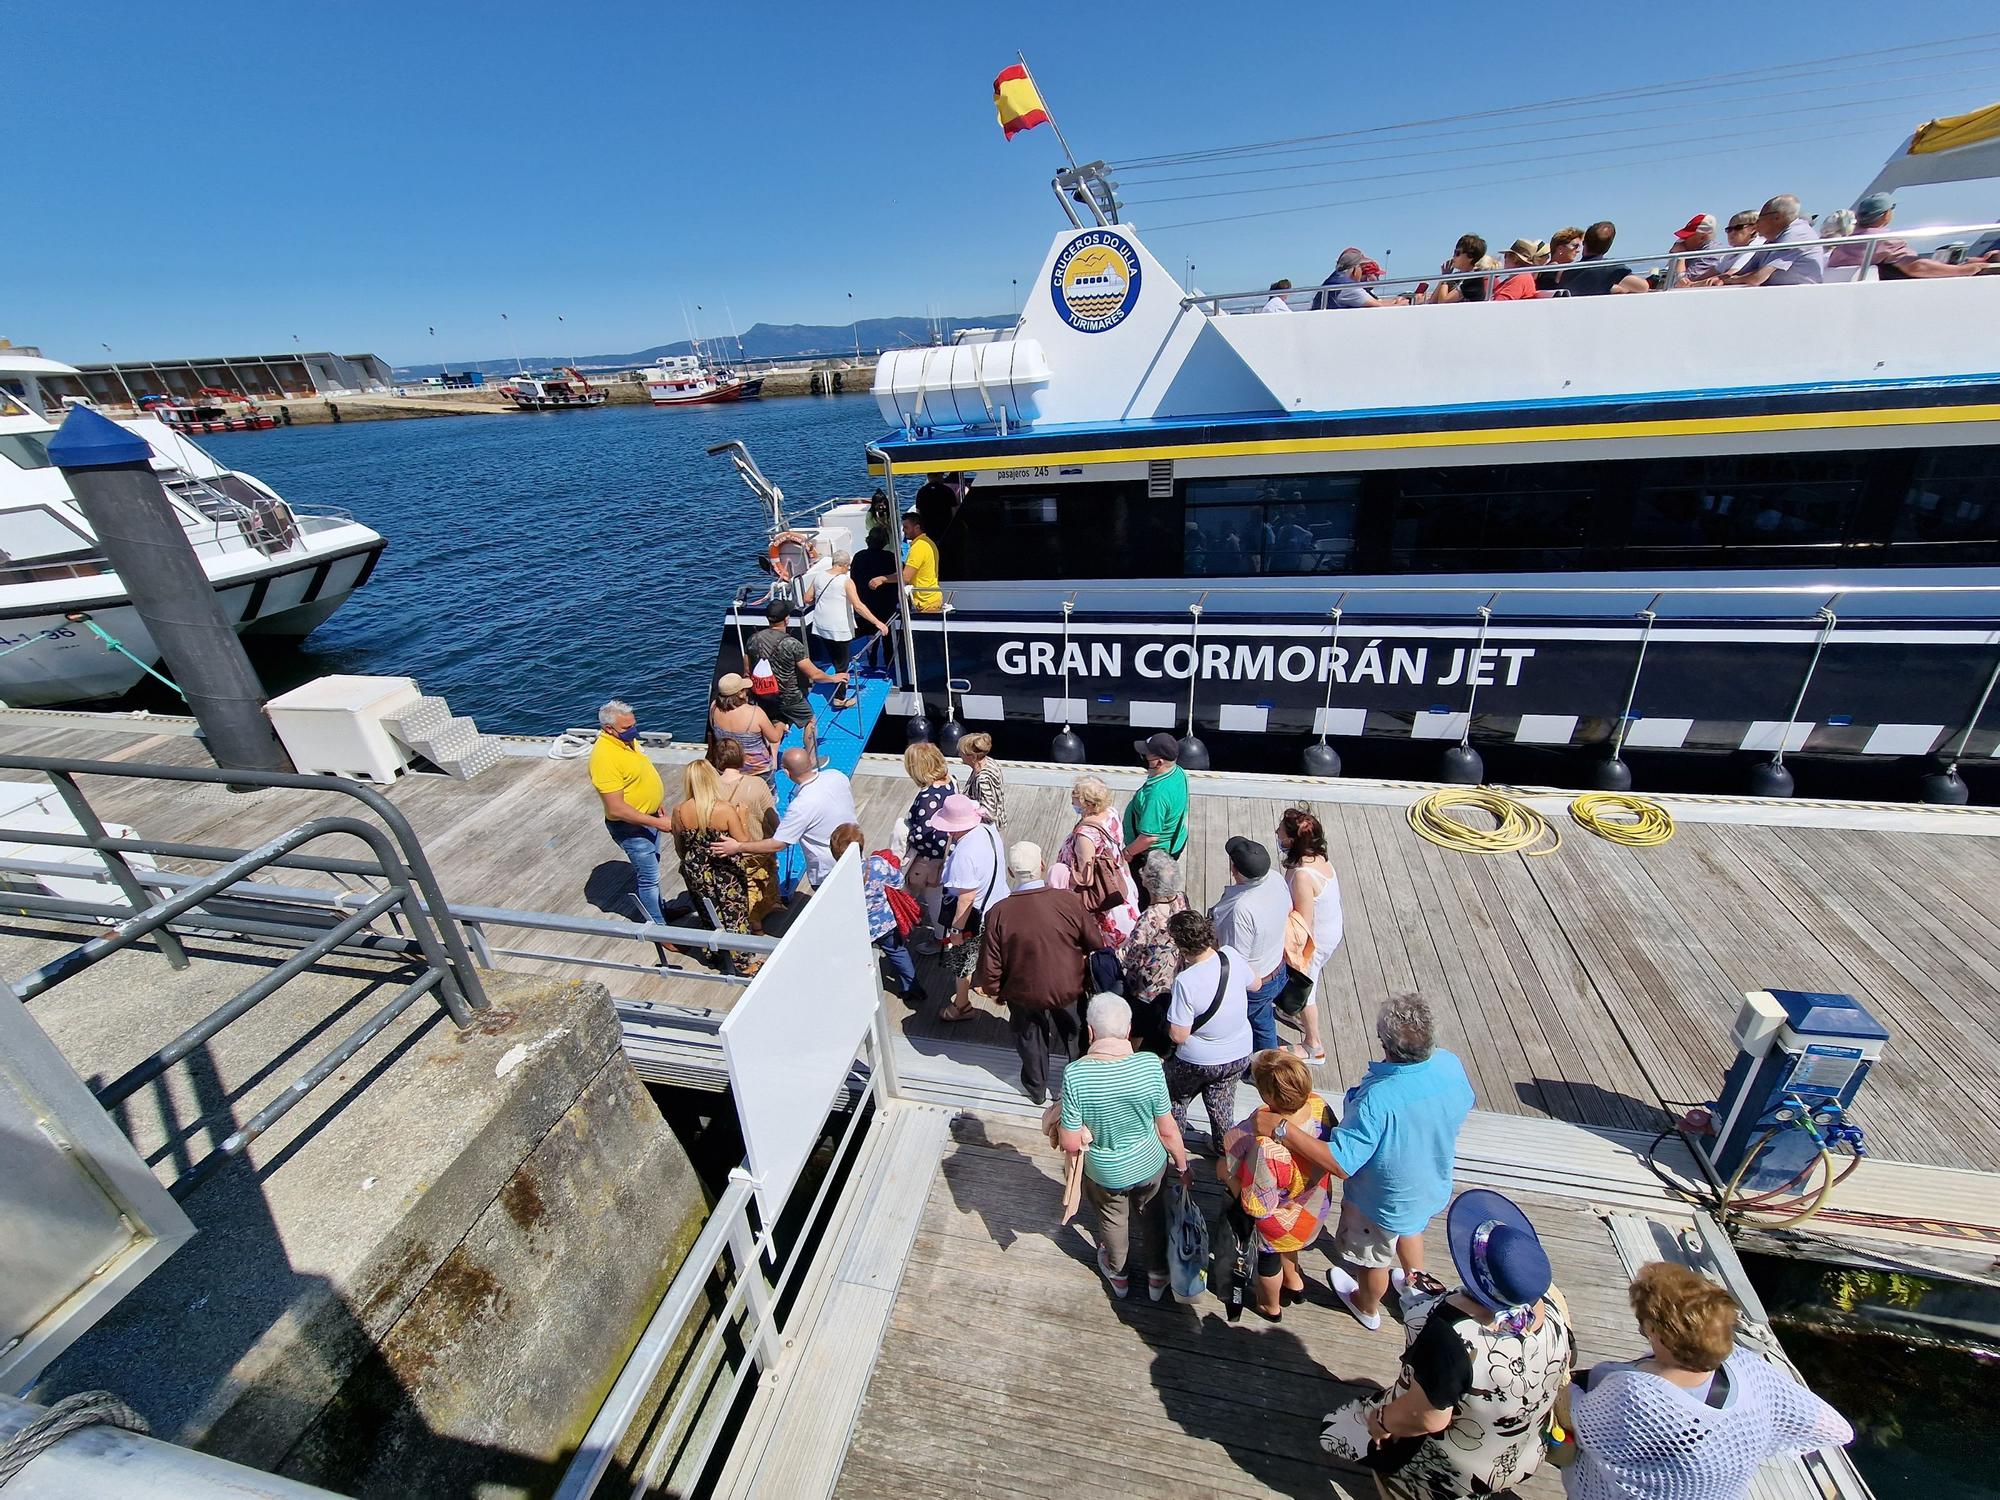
[718,117,2000,796]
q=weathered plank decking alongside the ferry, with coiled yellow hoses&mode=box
[0,716,2000,1172]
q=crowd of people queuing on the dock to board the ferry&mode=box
[590,704,1854,1500]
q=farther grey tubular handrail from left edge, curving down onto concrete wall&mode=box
[0,756,488,1024]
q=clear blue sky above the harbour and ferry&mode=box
[15,0,2000,364]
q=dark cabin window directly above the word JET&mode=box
[1390,464,1602,572]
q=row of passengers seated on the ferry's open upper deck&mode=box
[1258,192,2000,312]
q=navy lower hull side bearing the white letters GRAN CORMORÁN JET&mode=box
[718,604,2000,776]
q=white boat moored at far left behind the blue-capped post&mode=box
[0,352,386,708]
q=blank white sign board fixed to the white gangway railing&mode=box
[722,848,882,1224]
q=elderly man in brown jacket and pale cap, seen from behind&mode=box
[974,840,1104,1104]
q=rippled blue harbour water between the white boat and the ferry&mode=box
[202,396,884,736]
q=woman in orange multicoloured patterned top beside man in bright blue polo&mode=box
[1216,1048,1334,1322]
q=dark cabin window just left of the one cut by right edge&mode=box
[1626,452,1868,552]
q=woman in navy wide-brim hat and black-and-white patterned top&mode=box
[1320,1188,1576,1500]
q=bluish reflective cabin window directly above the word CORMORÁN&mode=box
[1182,474,1362,578]
